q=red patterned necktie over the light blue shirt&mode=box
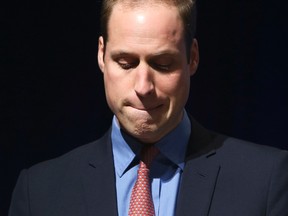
[128,146,159,216]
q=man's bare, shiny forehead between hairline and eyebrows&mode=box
[108,2,183,51]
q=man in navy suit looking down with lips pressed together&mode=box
[10,0,288,216]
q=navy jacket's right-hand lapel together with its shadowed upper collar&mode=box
[176,117,226,216]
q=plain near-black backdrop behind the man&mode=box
[0,0,288,215]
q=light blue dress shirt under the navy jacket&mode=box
[112,112,191,216]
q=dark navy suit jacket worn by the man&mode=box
[9,121,288,216]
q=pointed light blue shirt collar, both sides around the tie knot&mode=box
[111,111,191,177]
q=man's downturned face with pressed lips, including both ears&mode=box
[98,3,198,143]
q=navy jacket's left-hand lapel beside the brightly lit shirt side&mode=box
[82,131,118,216]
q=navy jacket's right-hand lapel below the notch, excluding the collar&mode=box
[176,154,220,216]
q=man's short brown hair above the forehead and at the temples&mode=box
[100,0,196,60]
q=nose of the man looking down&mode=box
[134,65,154,97]
